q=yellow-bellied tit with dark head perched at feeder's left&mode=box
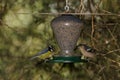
[30,45,54,60]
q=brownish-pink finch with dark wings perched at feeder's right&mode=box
[76,44,96,59]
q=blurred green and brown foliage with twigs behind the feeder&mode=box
[0,0,120,80]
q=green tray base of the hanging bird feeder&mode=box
[48,56,88,63]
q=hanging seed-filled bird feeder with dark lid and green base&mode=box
[50,14,86,63]
